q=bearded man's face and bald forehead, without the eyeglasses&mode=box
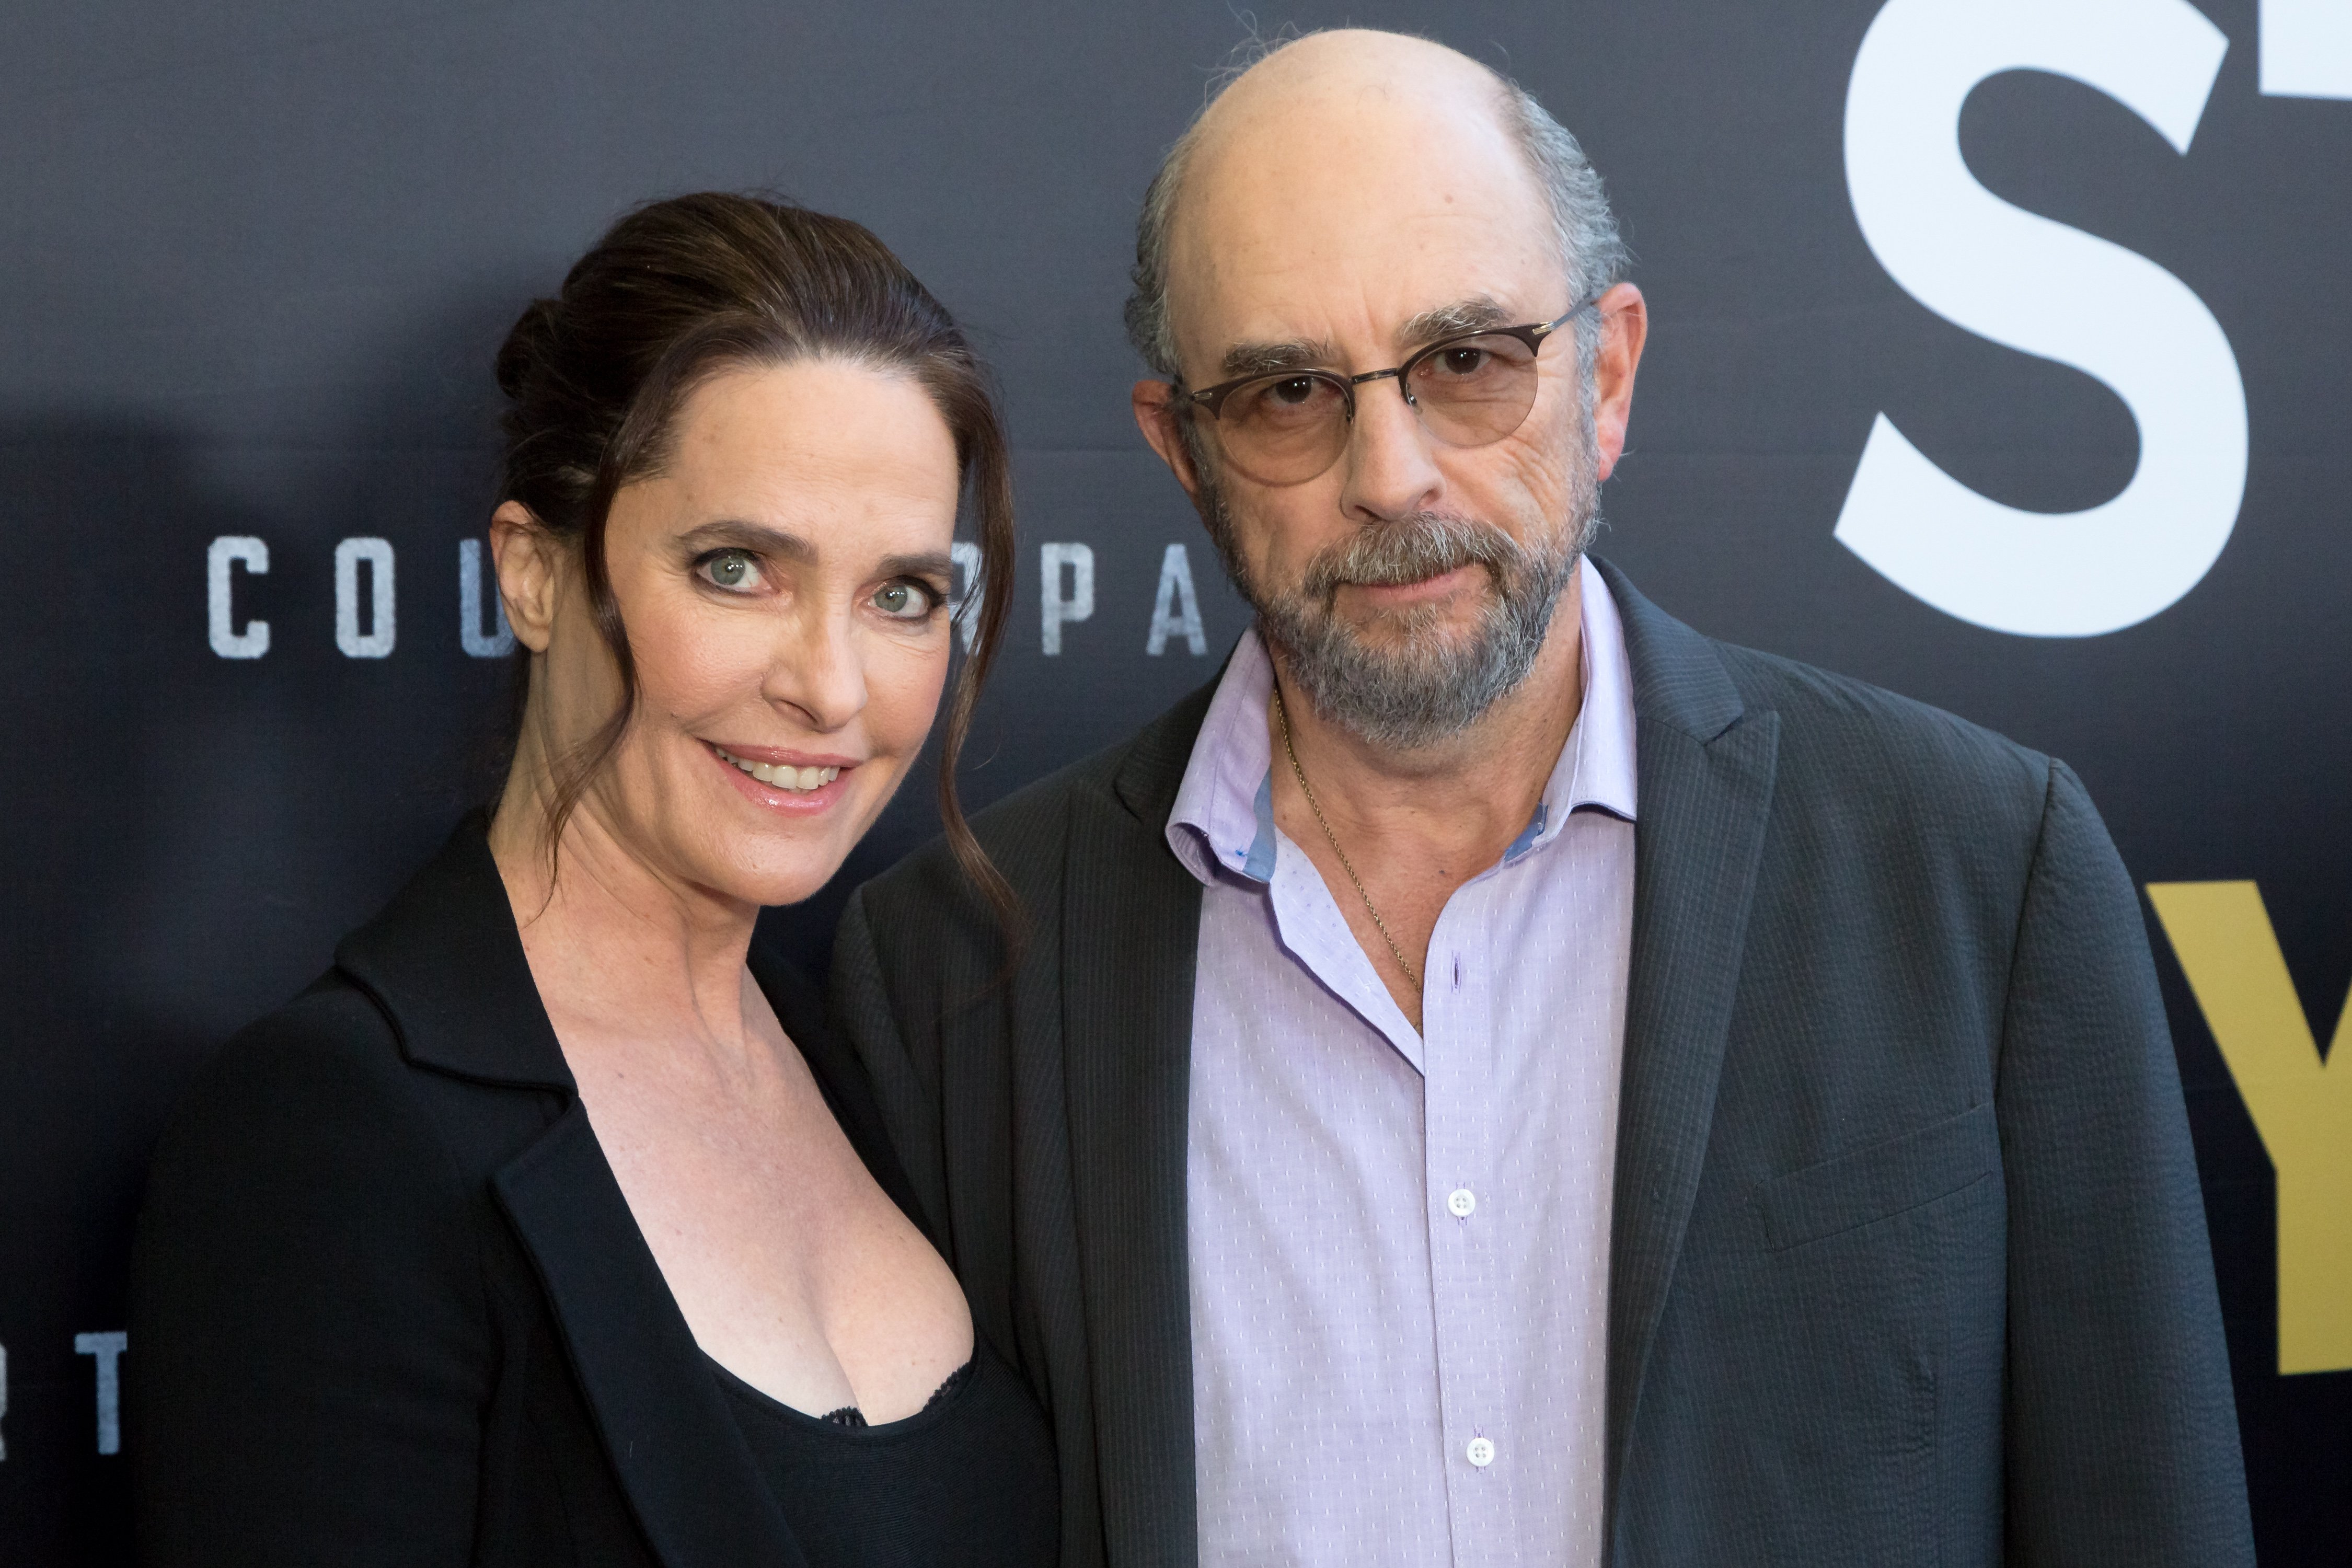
[1148,56,1623,747]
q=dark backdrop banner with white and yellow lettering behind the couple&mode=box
[0,0,2352,1568]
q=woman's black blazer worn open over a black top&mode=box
[125,816,983,1568]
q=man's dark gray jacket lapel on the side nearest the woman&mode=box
[1061,691,1207,1568]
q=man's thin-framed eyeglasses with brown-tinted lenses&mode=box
[1176,298,1599,485]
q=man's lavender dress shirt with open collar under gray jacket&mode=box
[1169,562,1635,1568]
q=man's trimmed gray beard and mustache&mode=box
[1195,435,1599,752]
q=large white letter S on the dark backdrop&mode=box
[1837,0,2246,637]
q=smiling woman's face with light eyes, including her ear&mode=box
[517,360,960,905]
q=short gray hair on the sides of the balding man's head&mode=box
[1127,38,1632,381]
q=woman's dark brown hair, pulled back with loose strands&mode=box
[499,193,1014,917]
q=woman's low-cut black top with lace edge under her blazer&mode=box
[710,1345,1061,1568]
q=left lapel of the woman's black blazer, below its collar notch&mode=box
[492,1100,807,1568]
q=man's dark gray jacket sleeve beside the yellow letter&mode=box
[1997,764,2253,1568]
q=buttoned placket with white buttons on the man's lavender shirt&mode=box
[1421,872,1517,1566]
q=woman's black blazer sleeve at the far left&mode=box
[125,987,492,1568]
